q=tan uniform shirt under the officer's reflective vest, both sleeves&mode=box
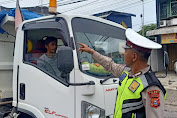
[93,52,165,118]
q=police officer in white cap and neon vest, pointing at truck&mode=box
[78,29,166,118]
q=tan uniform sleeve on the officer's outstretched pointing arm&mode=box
[93,52,125,77]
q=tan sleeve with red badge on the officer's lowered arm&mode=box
[142,86,165,118]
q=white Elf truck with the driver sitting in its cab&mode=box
[0,14,126,118]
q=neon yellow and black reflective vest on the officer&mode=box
[114,71,166,118]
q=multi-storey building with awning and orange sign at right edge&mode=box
[146,0,177,70]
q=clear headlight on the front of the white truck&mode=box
[81,101,105,118]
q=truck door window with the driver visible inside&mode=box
[24,29,67,81]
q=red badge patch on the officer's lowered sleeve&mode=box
[148,90,160,108]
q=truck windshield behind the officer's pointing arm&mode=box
[72,18,126,77]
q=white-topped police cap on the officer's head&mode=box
[124,28,162,52]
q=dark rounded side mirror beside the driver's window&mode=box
[57,46,74,74]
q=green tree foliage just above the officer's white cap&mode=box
[138,24,157,40]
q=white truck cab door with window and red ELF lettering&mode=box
[17,18,75,118]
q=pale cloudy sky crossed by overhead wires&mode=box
[0,0,156,31]
